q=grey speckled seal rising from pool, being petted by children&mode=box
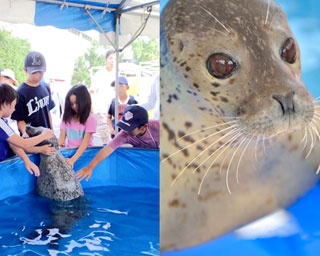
[26,125,84,201]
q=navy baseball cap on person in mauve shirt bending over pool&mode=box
[117,105,148,132]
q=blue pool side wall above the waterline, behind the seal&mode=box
[0,147,159,200]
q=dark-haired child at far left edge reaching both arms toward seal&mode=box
[0,84,54,176]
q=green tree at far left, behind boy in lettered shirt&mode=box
[0,29,31,83]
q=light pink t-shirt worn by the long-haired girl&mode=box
[60,113,97,147]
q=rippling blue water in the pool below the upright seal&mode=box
[0,186,159,256]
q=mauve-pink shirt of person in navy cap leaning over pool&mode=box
[108,120,160,150]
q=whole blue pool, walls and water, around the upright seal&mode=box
[0,147,160,256]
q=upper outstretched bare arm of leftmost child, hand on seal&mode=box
[7,129,54,149]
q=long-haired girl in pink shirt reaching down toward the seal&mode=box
[58,85,97,166]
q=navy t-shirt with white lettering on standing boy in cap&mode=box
[11,82,55,128]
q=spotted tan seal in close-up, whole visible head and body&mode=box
[160,0,320,251]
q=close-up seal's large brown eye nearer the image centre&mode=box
[207,53,238,79]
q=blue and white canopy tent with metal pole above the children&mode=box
[0,0,159,129]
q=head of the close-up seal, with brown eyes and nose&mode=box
[161,0,313,136]
